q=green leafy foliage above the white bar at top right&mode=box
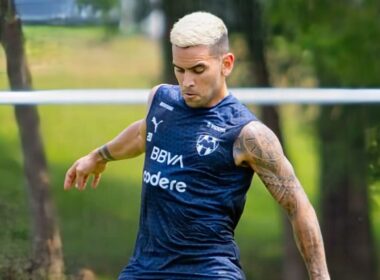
[267,0,380,87]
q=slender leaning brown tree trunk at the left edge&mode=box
[0,0,64,279]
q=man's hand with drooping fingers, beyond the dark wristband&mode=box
[64,151,107,190]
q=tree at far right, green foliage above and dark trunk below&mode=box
[270,0,380,280]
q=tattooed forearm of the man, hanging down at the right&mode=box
[290,201,330,280]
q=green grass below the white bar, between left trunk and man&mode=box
[41,106,145,279]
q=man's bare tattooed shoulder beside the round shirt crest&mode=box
[234,121,283,167]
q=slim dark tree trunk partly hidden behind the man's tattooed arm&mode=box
[236,0,307,280]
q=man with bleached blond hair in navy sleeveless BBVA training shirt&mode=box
[65,12,330,280]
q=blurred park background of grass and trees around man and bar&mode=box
[0,0,380,280]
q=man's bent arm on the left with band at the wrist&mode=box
[64,86,159,190]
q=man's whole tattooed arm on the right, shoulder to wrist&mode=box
[234,121,330,280]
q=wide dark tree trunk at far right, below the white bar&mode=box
[318,105,376,280]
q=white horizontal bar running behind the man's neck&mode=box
[0,88,380,105]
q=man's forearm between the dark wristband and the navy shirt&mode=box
[96,120,145,160]
